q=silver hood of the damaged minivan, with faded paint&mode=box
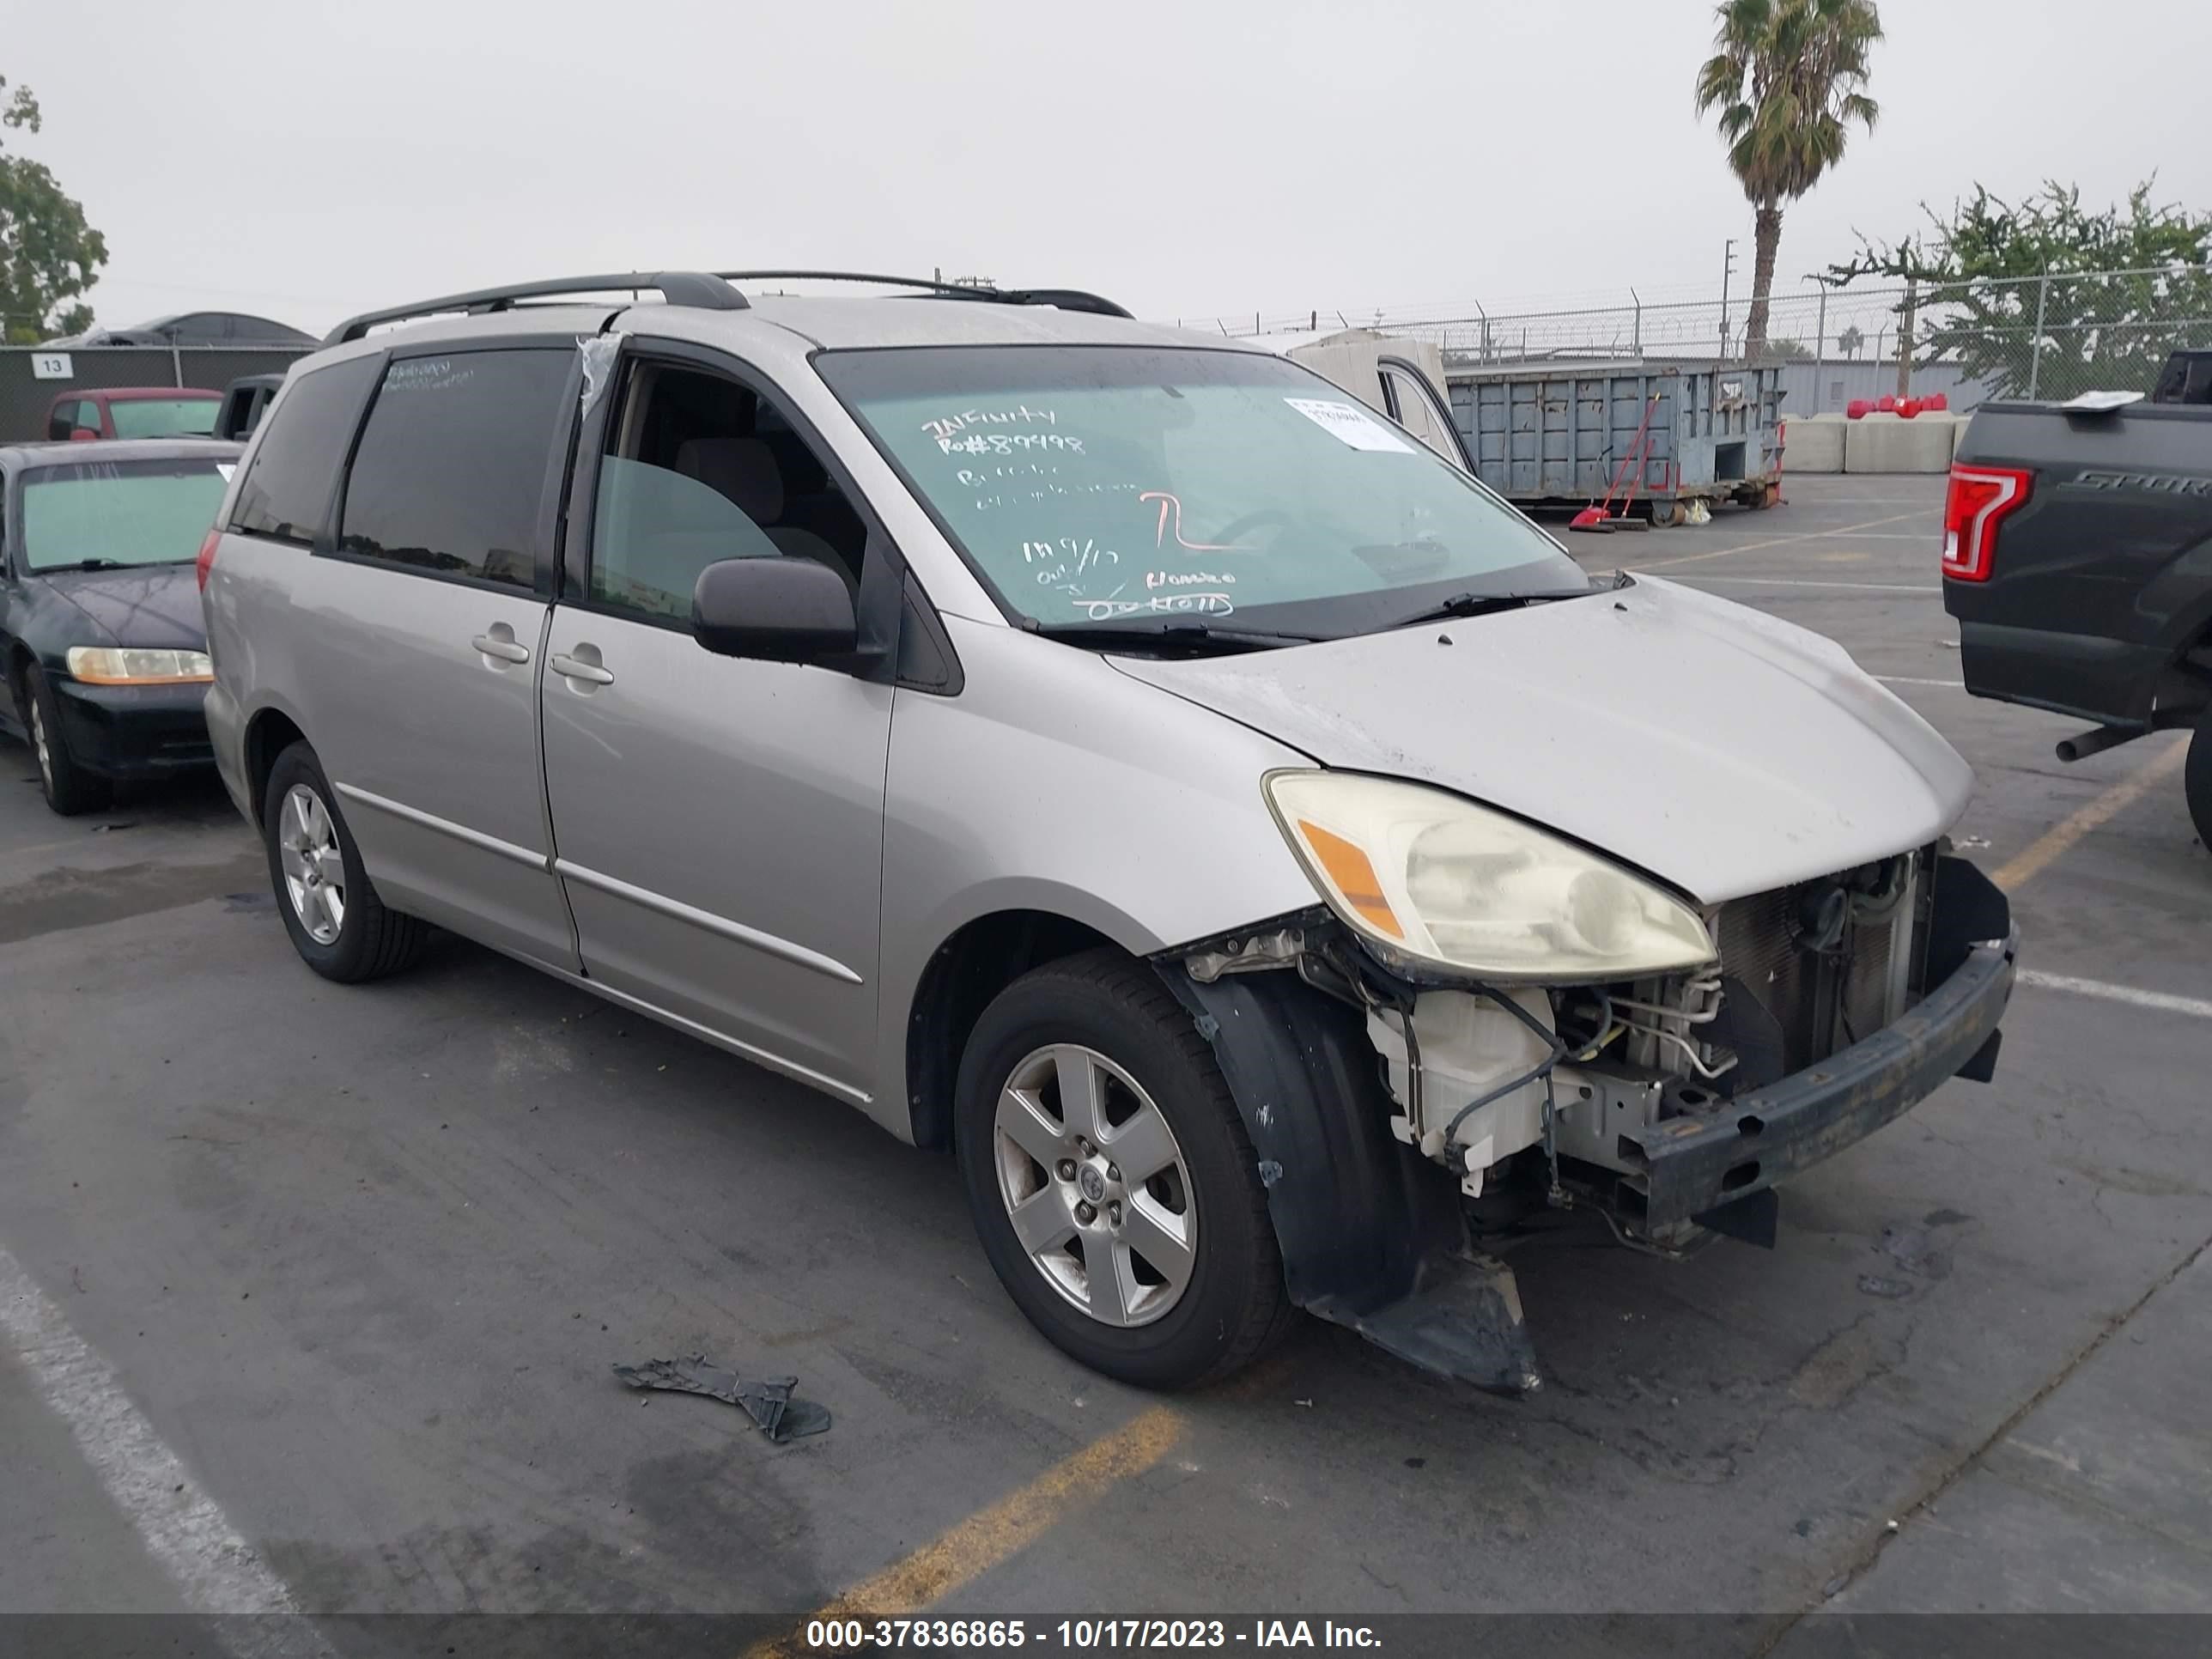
[1109,577,1973,902]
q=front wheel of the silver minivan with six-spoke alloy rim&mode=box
[953,951,1297,1389]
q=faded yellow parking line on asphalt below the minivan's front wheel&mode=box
[745,1405,1183,1659]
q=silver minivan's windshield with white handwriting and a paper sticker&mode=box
[814,345,1590,637]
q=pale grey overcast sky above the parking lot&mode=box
[17,0,2212,330]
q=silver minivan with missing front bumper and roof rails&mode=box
[199,272,2015,1391]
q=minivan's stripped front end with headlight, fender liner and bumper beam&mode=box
[1155,772,2017,1394]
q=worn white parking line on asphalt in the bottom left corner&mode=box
[0,1249,316,1627]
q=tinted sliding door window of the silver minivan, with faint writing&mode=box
[338,347,575,588]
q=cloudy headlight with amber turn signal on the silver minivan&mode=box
[1265,772,1717,984]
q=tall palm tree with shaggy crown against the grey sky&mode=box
[1697,0,1882,358]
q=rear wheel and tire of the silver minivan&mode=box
[261,744,429,984]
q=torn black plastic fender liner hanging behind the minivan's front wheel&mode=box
[1159,960,1537,1394]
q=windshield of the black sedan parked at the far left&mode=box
[22,453,237,571]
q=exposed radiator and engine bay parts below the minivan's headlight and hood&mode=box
[1186,849,1933,1249]
